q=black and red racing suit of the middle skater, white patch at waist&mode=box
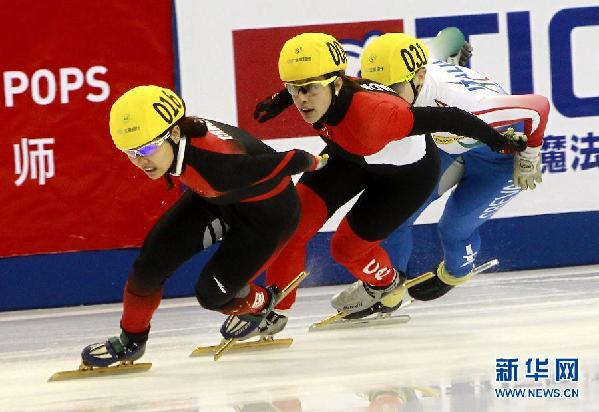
[267,77,505,309]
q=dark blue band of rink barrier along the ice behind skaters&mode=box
[0,212,599,311]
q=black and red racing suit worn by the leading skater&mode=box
[121,119,317,340]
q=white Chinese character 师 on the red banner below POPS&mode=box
[13,137,54,186]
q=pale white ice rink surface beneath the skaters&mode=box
[0,266,599,412]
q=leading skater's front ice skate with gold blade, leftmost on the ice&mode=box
[48,333,152,381]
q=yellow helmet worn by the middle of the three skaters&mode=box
[279,33,347,82]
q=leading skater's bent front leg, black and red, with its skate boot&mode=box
[82,192,226,366]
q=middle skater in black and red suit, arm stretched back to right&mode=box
[254,33,526,317]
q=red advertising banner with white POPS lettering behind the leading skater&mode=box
[0,0,176,257]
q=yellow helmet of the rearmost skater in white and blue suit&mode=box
[360,33,430,86]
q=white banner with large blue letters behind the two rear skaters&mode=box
[176,0,599,230]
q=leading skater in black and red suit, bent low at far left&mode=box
[82,86,326,367]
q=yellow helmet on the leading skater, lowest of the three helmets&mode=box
[110,85,185,150]
